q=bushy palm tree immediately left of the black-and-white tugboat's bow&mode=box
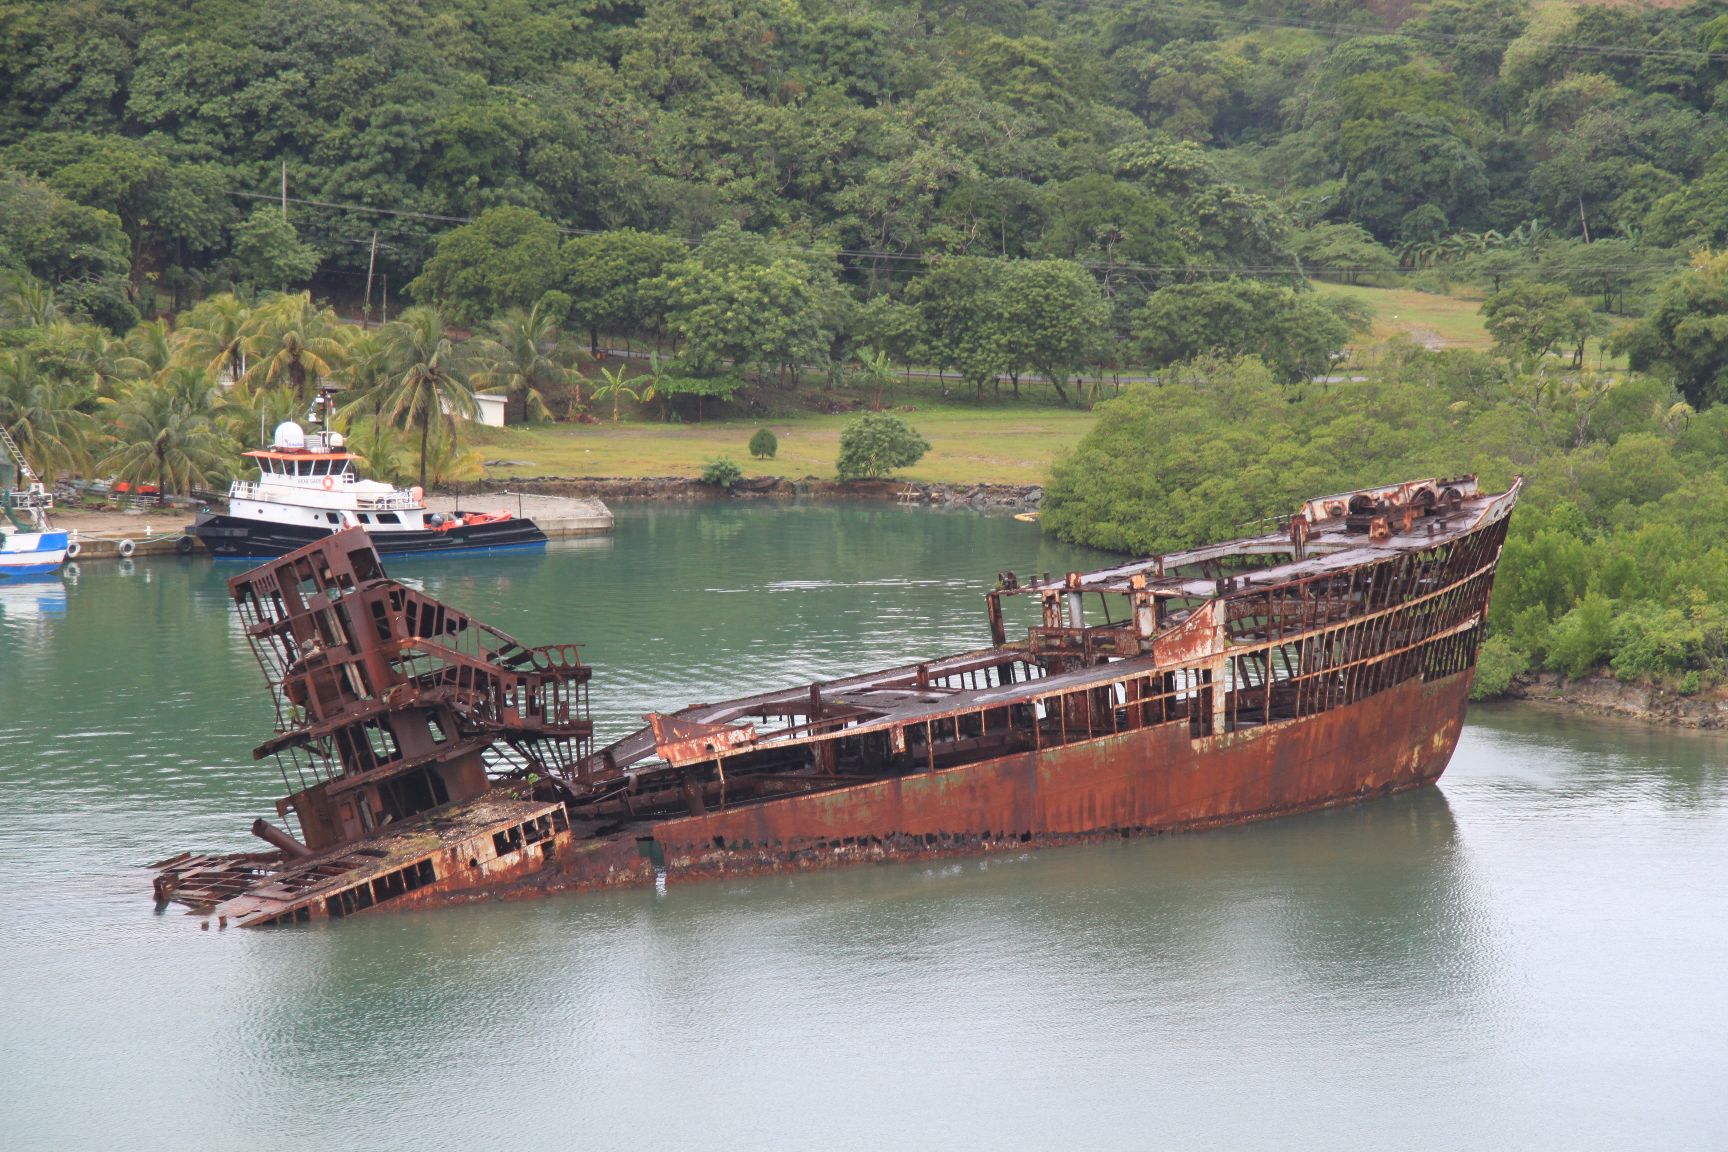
[98,368,233,499]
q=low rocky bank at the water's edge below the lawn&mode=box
[463,477,1044,511]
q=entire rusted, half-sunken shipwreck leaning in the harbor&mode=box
[154,477,1519,926]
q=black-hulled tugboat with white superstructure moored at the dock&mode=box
[192,392,546,558]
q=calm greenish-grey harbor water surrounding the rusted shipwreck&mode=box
[0,504,1728,1150]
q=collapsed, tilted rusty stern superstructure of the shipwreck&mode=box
[156,529,593,924]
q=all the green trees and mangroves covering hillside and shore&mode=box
[10,0,1728,687]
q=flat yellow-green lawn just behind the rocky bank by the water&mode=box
[473,401,1096,484]
